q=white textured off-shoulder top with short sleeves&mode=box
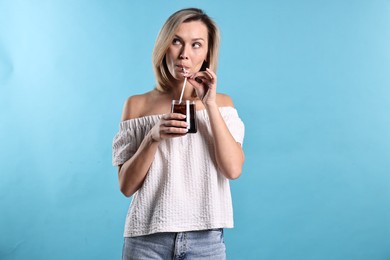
[112,107,244,237]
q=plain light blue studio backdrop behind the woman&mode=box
[0,0,390,260]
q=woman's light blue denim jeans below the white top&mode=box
[122,228,226,260]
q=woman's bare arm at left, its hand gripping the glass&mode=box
[118,98,187,197]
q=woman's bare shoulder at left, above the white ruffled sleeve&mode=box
[122,92,151,121]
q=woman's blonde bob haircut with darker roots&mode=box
[152,8,220,92]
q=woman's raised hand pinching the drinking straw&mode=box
[187,68,217,107]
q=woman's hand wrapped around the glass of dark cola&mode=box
[150,113,188,142]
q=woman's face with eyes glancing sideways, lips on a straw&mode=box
[165,21,208,80]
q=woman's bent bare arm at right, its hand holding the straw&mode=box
[189,69,244,179]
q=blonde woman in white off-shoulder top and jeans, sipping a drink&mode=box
[113,8,244,259]
